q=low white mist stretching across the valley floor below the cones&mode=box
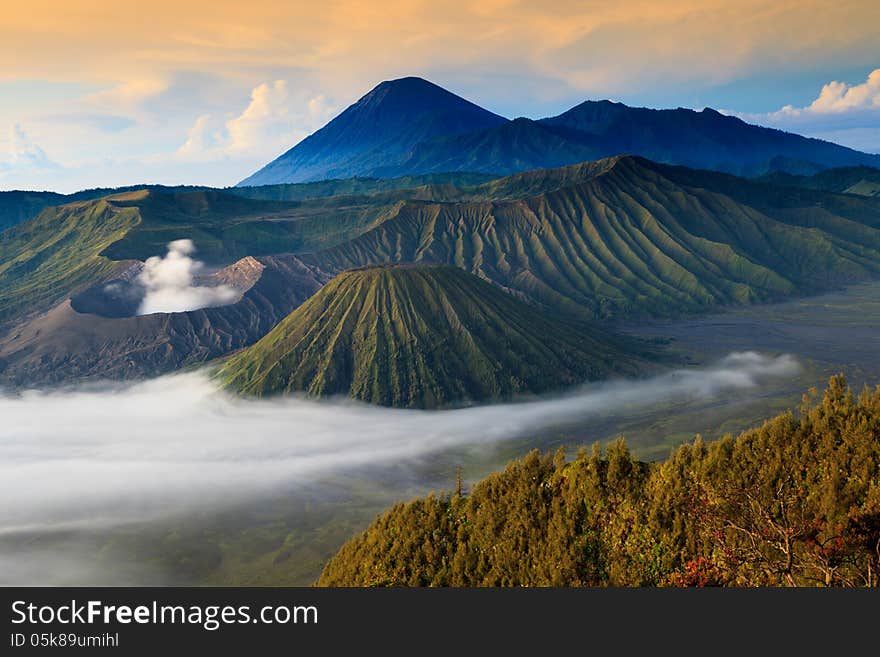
[0,352,798,540]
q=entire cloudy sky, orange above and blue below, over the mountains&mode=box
[0,0,880,192]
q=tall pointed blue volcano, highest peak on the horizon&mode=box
[240,77,507,186]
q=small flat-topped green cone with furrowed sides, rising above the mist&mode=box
[218,265,639,408]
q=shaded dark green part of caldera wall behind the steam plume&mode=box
[107,174,576,264]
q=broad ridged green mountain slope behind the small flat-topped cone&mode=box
[307,157,880,317]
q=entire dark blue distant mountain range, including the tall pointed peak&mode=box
[240,77,880,186]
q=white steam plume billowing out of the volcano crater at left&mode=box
[137,240,238,315]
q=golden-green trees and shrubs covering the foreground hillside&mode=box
[318,376,880,586]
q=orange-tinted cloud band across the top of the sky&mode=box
[0,0,880,89]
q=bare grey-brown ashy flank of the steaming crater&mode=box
[0,256,326,387]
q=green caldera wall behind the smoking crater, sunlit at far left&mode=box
[0,190,395,323]
